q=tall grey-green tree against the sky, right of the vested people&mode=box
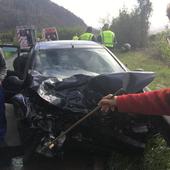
[111,0,152,48]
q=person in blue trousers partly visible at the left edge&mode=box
[0,49,7,145]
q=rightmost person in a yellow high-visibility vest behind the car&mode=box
[97,24,116,51]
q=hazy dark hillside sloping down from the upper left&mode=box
[0,0,86,31]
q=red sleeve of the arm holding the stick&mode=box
[116,88,170,115]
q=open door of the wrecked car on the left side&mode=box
[0,45,26,103]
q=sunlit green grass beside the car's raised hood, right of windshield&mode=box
[116,51,170,89]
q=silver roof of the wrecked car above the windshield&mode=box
[35,40,103,50]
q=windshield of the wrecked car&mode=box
[34,48,123,75]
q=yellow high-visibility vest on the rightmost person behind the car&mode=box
[100,30,115,47]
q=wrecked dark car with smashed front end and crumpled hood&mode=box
[1,41,170,162]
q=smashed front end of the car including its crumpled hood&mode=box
[13,71,159,157]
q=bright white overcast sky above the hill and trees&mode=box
[51,0,170,30]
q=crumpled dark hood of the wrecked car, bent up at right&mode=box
[28,72,155,113]
